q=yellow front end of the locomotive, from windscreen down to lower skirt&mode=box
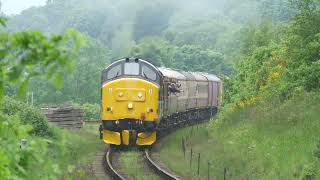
[101,58,160,146]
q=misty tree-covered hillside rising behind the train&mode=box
[8,0,295,103]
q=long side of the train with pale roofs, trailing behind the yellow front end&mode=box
[158,67,222,132]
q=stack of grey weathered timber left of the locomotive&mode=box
[41,107,83,128]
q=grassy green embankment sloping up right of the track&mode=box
[160,93,320,179]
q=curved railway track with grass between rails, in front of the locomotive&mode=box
[104,148,179,180]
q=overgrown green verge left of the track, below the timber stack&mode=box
[0,98,100,179]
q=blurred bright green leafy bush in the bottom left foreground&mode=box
[0,114,56,179]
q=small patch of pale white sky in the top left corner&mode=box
[0,0,47,15]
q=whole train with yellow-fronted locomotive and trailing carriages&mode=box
[99,58,222,146]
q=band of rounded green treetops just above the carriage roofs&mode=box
[129,37,232,74]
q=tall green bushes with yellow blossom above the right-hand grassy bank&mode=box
[225,0,320,104]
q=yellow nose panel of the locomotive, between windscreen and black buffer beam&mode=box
[102,78,159,121]
